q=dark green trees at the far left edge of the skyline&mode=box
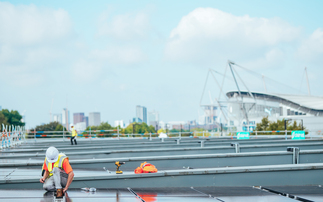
[0,109,25,128]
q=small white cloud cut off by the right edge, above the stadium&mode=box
[297,28,323,61]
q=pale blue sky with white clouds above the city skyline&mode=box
[0,0,323,128]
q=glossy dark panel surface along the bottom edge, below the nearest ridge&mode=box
[0,186,323,202]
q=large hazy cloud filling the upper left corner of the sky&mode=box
[0,2,73,86]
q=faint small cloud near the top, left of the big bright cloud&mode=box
[98,13,149,40]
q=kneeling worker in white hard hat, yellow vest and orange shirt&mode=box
[39,147,74,198]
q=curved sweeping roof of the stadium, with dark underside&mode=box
[226,91,323,115]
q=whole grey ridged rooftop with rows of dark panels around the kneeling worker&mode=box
[0,139,323,202]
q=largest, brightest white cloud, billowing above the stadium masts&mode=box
[165,8,301,64]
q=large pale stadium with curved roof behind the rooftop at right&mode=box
[226,91,323,134]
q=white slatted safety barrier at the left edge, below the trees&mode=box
[0,124,25,150]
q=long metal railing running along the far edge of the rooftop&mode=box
[5,126,323,143]
